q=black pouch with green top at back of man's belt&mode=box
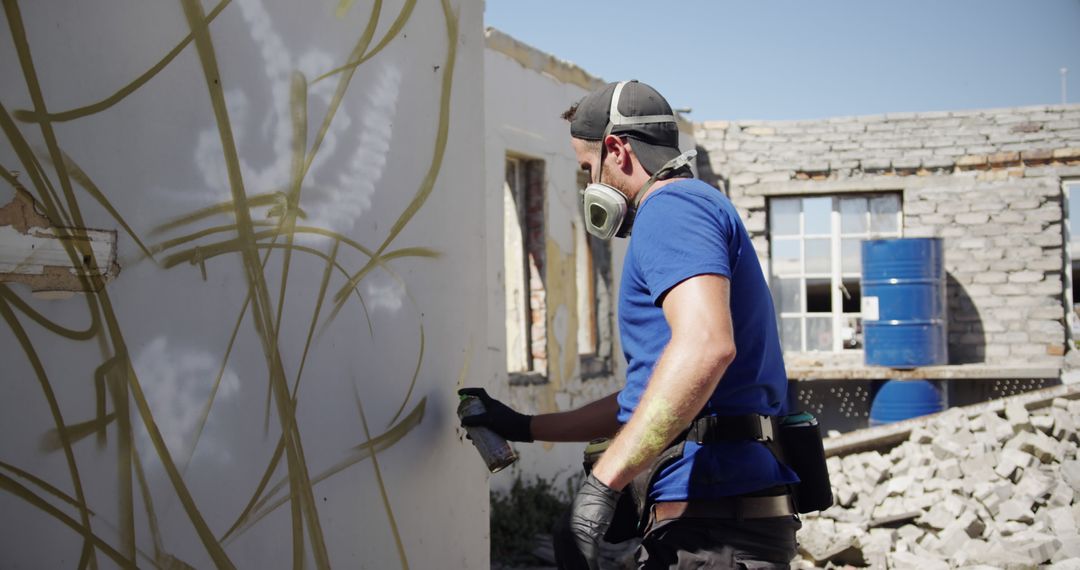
[773,411,833,513]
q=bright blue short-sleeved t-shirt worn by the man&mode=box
[619,179,798,501]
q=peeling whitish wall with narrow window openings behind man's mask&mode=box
[484,29,693,488]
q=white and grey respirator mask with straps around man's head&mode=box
[581,81,698,240]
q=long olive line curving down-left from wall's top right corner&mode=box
[334,0,458,314]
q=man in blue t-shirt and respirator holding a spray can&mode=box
[467,81,799,568]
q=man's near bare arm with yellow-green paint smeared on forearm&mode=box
[593,274,735,489]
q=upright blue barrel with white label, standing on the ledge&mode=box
[862,238,948,368]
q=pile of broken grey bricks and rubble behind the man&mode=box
[793,398,1080,570]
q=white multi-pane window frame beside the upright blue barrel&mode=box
[767,197,904,354]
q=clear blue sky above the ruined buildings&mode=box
[485,0,1080,121]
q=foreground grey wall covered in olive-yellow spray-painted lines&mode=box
[0,0,490,568]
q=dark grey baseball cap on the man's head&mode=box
[570,80,679,174]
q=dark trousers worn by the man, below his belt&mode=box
[636,515,802,570]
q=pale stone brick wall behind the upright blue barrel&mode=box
[697,105,1080,365]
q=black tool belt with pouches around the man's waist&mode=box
[584,412,833,543]
